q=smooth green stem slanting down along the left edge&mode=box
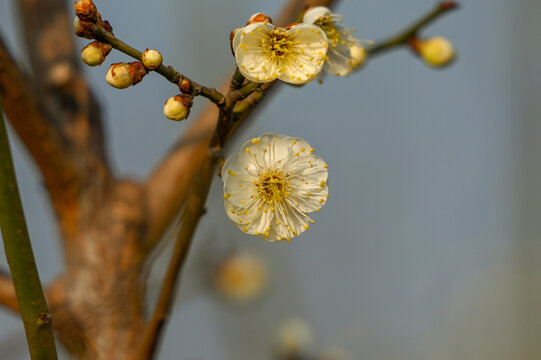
[0,99,57,360]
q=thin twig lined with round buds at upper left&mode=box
[92,24,225,106]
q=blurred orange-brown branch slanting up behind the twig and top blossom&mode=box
[146,0,336,247]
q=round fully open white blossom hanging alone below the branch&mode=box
[222,133,329,241]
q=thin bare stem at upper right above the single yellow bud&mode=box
[366,1,458,56]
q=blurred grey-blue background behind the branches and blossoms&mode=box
[0,0,541,360]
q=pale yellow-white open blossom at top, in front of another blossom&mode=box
[232,22,328,84]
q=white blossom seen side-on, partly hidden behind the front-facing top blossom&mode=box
[303,6,366,76]
